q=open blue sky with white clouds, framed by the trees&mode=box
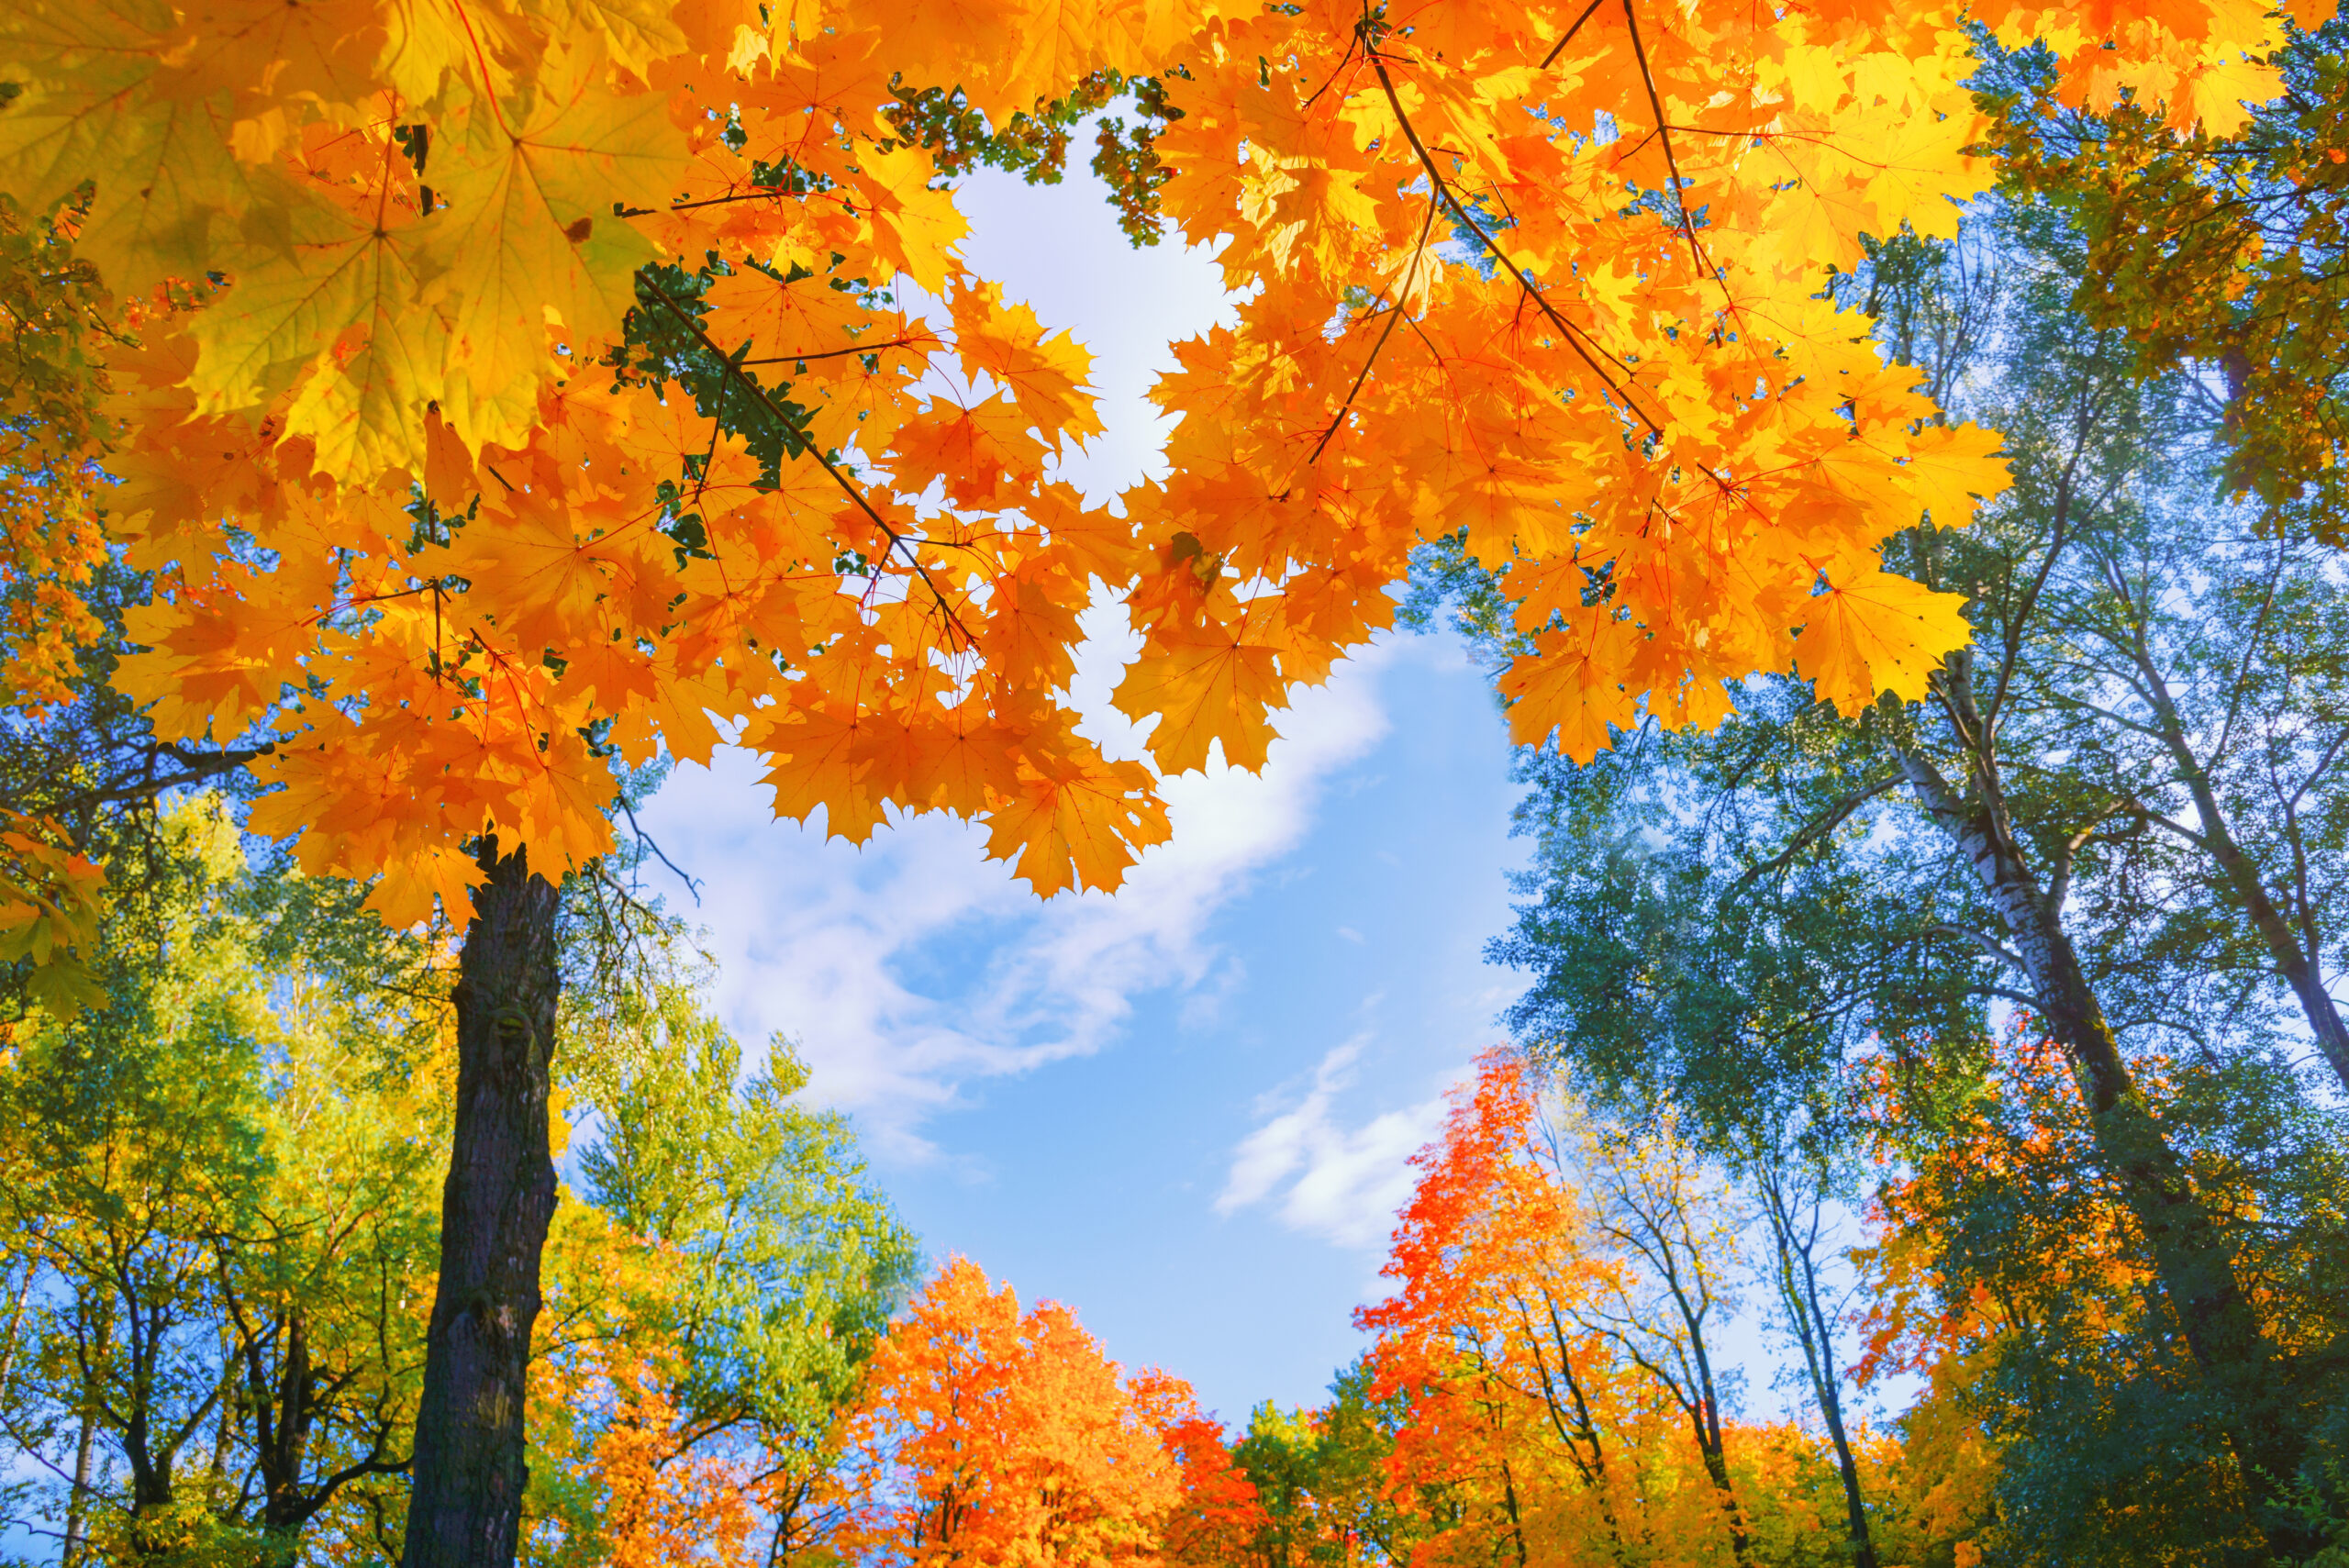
[646,136,1804,1422]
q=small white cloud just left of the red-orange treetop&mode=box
[1215,1035,1444,1247]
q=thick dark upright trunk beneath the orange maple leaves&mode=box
[399,838,562,1568]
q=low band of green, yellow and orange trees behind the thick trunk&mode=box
[0,774,2349,1568]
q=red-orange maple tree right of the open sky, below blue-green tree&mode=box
[1362,1050,1959,1563]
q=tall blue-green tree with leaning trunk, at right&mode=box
[1435,206,2349,1561]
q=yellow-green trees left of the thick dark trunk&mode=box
[0,798,441,1563]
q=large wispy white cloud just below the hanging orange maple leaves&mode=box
[646,628,1391,1160]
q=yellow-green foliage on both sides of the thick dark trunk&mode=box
[0,795,918,1568]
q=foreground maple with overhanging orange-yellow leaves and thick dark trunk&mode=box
[0,0,2277,1561]
